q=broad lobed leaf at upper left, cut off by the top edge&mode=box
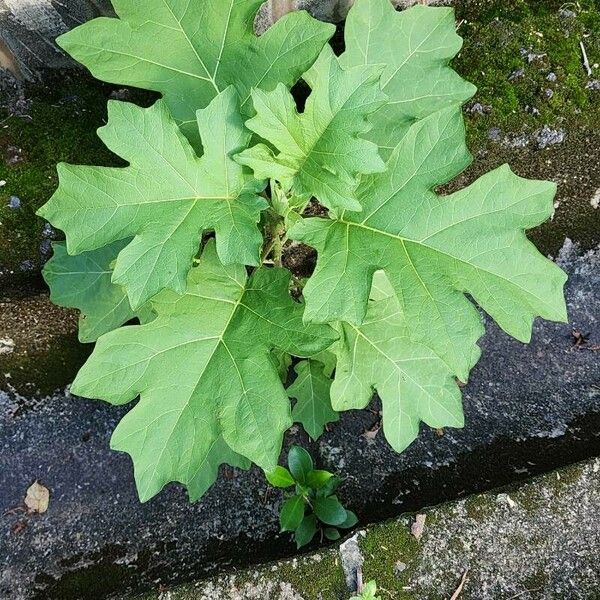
[57,0,335,147]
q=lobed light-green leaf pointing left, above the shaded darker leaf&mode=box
[39,88,267,309]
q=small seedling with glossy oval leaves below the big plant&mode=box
[267,446,358,548]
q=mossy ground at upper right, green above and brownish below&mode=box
[448,0,600,255]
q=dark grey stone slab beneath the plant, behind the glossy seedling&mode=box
[0,244,600,600]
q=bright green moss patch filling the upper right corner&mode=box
[454,0,600,142]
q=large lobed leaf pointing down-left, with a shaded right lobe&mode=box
[72,242,336,500]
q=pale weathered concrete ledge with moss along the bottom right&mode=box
[135,459,600,600]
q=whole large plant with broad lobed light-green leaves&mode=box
[39,0,566,506]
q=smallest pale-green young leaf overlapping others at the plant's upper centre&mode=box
[237,46,386,210]
